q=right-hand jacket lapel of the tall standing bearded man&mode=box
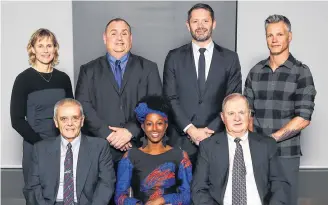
[203,43,225,95]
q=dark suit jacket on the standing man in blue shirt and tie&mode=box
[75,54,162,161]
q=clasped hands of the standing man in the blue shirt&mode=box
[107,126,132,149]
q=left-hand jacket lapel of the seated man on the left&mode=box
[48,136,61,198]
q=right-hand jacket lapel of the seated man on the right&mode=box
[248,132,265,196]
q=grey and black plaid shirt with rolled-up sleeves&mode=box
[244,54,316,157]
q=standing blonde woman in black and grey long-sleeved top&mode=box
[10,28,73,182]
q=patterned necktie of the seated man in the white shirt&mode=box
[232,138,247,205]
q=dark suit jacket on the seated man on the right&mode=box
[191,132,289,205]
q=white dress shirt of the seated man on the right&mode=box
[223,132,262,205]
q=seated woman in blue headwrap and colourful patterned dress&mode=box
[115,96,192,205]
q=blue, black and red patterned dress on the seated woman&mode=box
[115,148,192,205]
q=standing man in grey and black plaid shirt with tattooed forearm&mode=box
[244,15,316,205]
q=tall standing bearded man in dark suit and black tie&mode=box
[163,3,242,165]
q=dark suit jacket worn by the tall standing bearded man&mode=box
[163,43,242,155]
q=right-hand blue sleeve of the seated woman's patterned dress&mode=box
[163,152,192,205]
